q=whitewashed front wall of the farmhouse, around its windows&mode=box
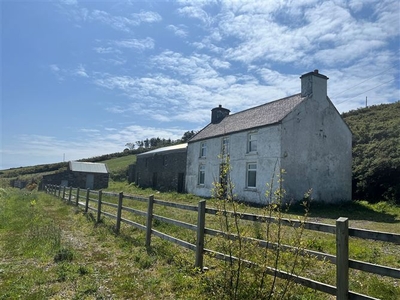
[186,125,281,204]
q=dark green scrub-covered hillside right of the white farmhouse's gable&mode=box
[342,101,400,203]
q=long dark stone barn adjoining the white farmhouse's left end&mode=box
[135,143,187,193]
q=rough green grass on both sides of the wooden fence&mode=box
[0,185,400,300]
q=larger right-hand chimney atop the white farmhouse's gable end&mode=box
[300,70,329,99]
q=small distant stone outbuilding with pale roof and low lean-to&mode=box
[42,161,109,189]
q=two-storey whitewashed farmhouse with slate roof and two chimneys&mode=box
[186,70,352,204]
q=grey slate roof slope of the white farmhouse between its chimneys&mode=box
[189,94,306,143]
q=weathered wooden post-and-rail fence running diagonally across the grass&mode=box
[45,185,400,300]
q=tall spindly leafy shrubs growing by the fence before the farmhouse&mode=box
[208,156,313,299]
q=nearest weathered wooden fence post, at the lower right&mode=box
[336,217,349,300]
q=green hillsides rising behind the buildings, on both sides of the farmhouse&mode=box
[0,101,400,203]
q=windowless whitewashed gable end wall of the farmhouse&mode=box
[282,93,352,202]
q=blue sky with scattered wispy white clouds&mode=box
[0,0,400,169]
